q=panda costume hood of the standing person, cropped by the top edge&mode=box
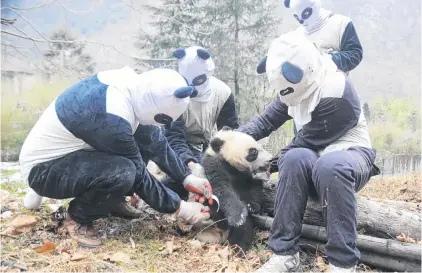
[284,0,331,34]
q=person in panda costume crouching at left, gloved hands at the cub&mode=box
[19,67,212,247]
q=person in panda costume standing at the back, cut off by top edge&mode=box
[284,0,363,73]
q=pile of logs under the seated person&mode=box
[254,182,422,272]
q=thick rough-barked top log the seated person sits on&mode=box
[263,182,421,240]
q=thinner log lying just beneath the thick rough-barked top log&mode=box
[253,215,422,262]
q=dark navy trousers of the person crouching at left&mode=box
[28,150,136,224]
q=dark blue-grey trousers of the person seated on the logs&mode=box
[269,147,376,267]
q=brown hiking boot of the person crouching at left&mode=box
[63,216,101,248]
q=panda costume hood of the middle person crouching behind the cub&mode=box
[173,46,215,102]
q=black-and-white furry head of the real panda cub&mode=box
[206,126,272,176]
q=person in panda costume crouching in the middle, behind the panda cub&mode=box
[166,46,239,198]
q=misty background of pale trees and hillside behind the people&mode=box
[1,0,421,174]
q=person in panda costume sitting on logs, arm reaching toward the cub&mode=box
[238,31,379,272]
